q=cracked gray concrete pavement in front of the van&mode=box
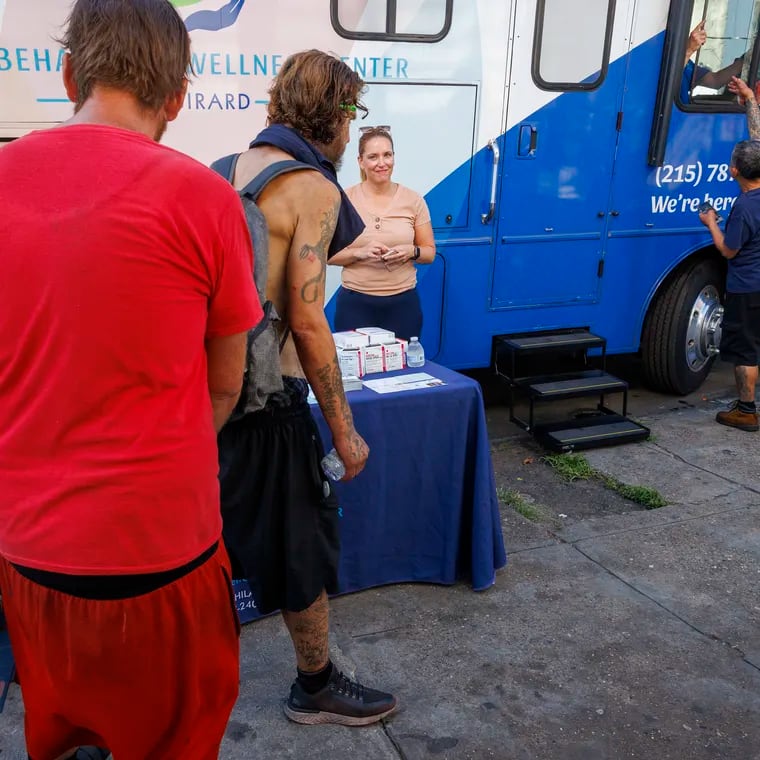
[0,394,760,760]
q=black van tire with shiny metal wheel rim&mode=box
[641,259,725,396]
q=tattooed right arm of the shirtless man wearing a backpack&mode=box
[286,172,369,480]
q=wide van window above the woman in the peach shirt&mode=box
[330,0,452,42]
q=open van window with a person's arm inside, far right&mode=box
[677,0,760,111]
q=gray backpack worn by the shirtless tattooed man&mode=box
[211,153,314,421]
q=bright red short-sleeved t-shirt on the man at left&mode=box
[0,125,262,574]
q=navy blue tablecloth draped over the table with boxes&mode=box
[236,362,506,622]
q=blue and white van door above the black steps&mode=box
[491,0,633,309]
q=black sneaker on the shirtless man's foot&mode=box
[285,667,396,726]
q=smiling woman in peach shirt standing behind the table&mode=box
[329,127,435,339]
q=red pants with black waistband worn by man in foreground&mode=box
[0,542,240,760]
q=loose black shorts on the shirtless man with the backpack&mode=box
[218,403,340,614]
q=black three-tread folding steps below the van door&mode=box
[494,328,649,452]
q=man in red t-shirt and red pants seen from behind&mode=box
[0,0,262,760]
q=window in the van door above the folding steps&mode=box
[532,0,615,90]
